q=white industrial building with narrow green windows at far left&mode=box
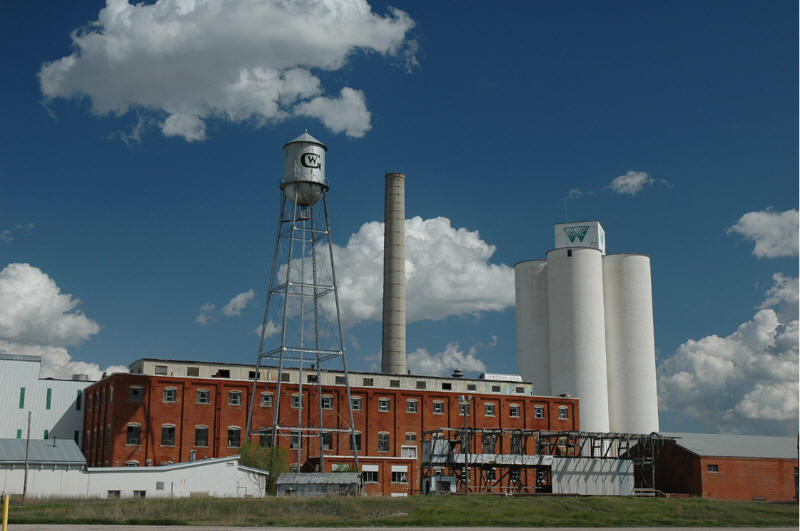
[0,354,94,445]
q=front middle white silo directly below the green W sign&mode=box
[547,247,609,432]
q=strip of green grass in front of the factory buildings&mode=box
[9,495,798,527]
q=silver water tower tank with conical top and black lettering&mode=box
[281,131,328,207]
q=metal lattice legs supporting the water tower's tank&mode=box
[246,188,358,471]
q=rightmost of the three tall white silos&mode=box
[604,254,658,433]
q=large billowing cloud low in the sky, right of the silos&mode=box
[659,273,798,434]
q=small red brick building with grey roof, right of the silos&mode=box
[656,433,798,502]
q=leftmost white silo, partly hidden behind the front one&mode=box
[514,260,552,395]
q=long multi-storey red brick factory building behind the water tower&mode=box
[83,359,580,495]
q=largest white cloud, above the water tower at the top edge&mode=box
[39,0,417,141]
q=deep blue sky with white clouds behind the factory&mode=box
[0,0,798,435]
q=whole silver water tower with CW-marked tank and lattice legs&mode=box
[246,131,358,471]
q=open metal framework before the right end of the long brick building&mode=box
[422,426,670,494]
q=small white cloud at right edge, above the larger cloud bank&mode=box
[728,209,798,258]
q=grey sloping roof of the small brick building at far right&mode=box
[661,433,798,459]
